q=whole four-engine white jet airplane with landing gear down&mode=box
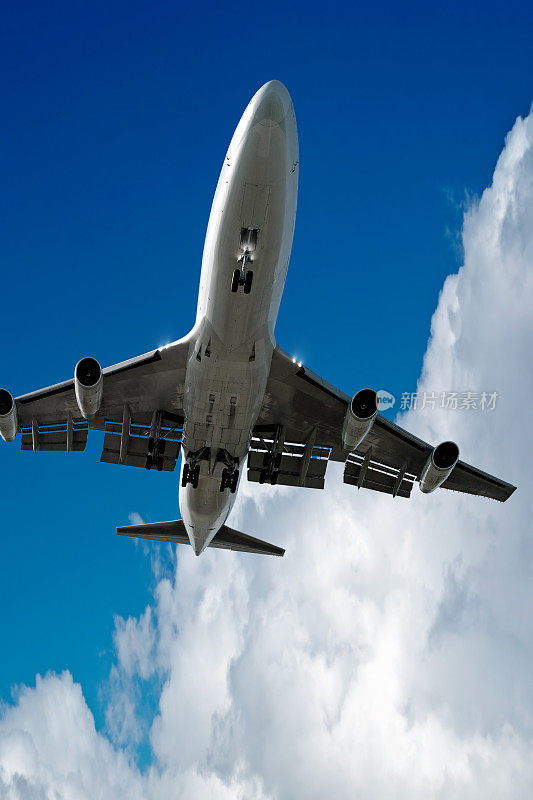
[0,80,516,556]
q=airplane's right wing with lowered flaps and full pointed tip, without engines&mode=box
[252,347,516,501]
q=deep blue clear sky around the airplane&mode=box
[0,3,533,752]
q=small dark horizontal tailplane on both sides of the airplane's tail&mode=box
[117,519,285,556]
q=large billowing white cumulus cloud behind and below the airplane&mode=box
[0,109,533,800]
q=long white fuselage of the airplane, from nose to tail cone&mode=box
[179,81,298,555]
